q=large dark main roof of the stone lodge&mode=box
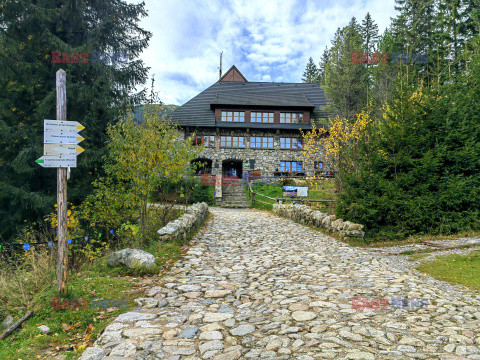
[172,81,329,127]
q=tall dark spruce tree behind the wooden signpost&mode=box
[0,0,151,240]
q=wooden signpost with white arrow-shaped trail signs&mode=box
[36,69,84,294]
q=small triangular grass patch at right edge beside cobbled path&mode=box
[417,251,480,290]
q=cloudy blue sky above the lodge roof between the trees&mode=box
[128,0,395,105]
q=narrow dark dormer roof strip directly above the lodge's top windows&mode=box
[210,91,315,109]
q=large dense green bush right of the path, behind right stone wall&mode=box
[336,65,480,240]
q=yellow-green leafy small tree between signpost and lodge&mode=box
[83,106,202,226]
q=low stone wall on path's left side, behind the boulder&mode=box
[157,202,208,240]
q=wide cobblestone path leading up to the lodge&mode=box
[82,208,480,360]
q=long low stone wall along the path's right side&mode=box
[273,204,365,239]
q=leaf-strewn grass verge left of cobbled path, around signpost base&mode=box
[0,214,210,360]
